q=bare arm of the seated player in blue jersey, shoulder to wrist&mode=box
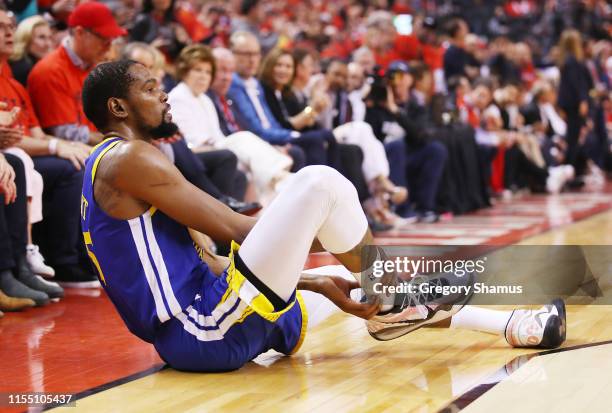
[94,141,256,243]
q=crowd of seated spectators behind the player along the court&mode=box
[0,0,612,314]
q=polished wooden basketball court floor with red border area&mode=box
[0,188,612,413]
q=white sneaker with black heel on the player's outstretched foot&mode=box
[505,299,566,348]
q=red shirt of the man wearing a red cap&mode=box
[28,46,96,131]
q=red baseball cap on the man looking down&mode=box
[68,1,127,39]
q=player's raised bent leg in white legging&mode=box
[238,166,370,301]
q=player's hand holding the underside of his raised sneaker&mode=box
[316,276,380,320]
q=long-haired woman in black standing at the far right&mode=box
[557,30,593,175]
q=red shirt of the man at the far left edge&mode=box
[0,62,39,136]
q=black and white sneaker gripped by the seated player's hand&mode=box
[366,273,475,341]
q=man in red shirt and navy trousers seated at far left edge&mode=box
[0,10,99,290]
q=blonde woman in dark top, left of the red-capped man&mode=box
[9,16,53,86]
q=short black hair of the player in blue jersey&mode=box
[82,60,140,131]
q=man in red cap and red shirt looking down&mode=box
[28,2,127,144]
